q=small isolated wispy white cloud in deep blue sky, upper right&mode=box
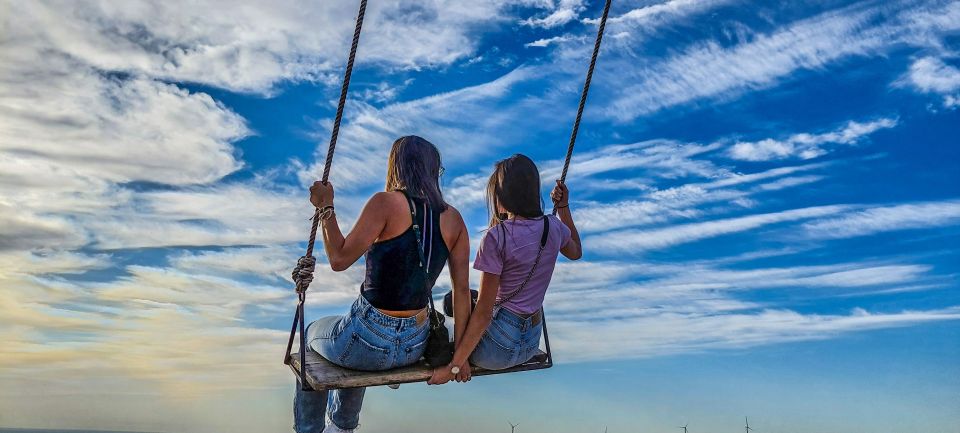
[727,118,898,161]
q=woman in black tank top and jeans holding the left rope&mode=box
[294,136,470,433]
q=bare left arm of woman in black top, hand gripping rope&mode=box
[310,182,387,272]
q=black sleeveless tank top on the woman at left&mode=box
[360,194,450,311]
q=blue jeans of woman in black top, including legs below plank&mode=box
[293,296,430,433]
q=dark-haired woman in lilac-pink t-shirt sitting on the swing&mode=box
[428,154,582,385]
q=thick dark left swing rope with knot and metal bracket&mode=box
[283,0,367,390]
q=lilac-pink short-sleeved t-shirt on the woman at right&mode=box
[473,215,570,315]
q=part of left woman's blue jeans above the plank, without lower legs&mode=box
[306,296,430,371]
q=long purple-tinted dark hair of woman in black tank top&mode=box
[386,135,447,212]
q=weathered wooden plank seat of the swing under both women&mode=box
[290,350,553,391]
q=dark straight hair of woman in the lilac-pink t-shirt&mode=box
[487,153,543,227]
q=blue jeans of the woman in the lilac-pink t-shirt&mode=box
[470,308,543,370]
